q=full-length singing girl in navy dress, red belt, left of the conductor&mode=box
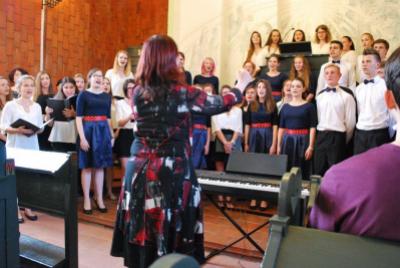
[76,68,113,214]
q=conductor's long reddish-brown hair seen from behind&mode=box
[135,35,183,100]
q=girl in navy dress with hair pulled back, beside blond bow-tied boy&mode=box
[277,78,317,180]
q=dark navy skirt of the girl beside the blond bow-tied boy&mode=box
[281,133,311,180]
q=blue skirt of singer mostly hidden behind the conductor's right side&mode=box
[192,128,207,169]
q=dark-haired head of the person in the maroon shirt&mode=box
[385,47,400,106]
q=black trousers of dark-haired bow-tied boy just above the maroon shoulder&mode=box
[354,128,390,154]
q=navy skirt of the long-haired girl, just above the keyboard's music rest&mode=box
[249,127,273,154]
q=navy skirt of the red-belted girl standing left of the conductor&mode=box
[78,120,113,169]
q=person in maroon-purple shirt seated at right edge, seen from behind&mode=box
[310,47,400,241]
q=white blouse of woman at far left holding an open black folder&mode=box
[1,100,43,150]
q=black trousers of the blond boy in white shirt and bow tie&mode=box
[314,131,347,176]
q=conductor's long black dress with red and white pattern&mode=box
[111,83,241,267]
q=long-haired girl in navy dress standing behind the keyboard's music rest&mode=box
[245,80,278,210]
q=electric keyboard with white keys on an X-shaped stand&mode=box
[196,169,309,199]
